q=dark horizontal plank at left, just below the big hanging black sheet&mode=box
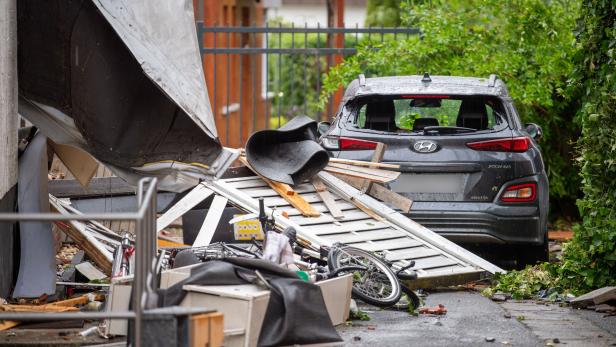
[47,177,135,198]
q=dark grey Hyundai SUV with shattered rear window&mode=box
[319,74,548,266]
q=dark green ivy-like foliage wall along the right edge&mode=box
[560,0,616,290]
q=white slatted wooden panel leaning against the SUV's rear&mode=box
[208,172,503,287]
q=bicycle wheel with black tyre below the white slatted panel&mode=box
[327,246,402,307]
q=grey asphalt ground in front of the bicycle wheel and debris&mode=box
[338,291,545,347]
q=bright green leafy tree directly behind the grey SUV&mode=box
[321,0,579,212]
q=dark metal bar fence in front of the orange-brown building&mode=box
[197,22,419,147]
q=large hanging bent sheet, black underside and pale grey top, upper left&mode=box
[18,0,223,174]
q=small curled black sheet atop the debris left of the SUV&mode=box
[246,116,329,185]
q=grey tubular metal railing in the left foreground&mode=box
[0,178,156,346]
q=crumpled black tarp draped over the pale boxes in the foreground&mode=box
[159,258,342,347]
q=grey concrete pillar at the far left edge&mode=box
[0,0,18,298]
